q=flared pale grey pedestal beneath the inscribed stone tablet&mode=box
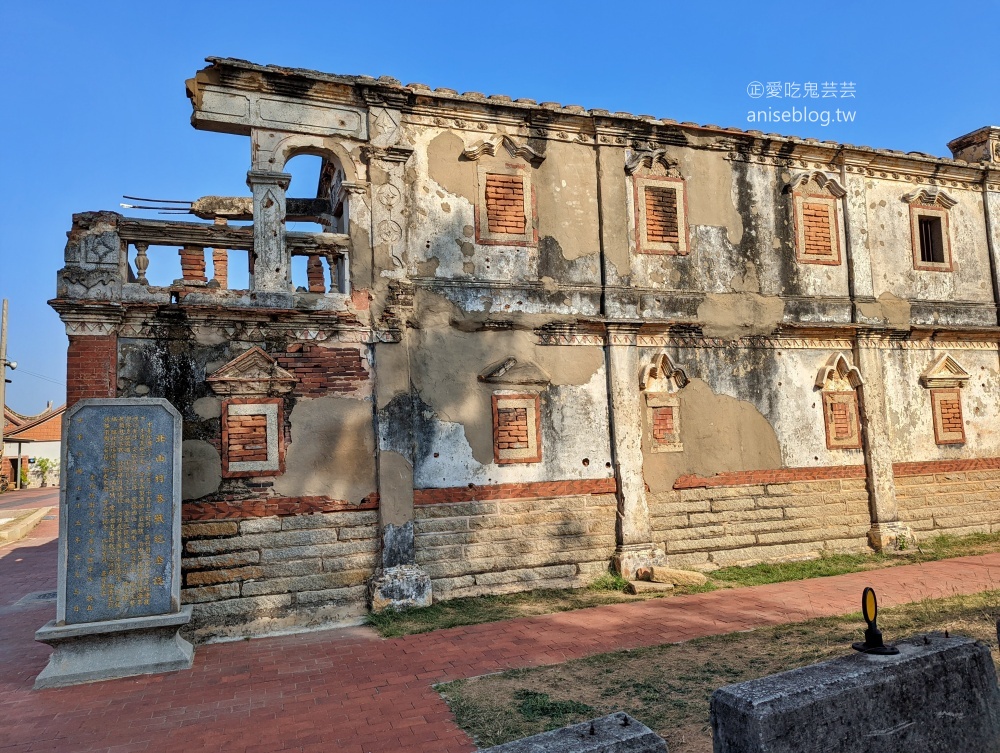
[35,606,194,689]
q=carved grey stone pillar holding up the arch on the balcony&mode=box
[247,170,292,308]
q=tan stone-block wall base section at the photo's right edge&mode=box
[896,459,1000,541]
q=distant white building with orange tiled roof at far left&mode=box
[0,402,66,487]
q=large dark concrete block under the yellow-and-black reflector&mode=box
[711,633,1000,753]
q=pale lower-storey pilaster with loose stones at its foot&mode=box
[606,322,666,580]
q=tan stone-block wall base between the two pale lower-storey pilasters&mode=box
[649,469,871,570]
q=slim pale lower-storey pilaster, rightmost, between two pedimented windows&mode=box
[854,335,913,552]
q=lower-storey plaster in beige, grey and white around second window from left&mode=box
[411,318,612,488]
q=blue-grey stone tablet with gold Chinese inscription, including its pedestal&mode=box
[35,398,194,688]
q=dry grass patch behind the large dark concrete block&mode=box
[437,591,1000,753]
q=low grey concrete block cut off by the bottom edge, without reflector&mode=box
[482,712,667,753]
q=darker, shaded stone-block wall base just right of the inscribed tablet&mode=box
[181,510,378,640]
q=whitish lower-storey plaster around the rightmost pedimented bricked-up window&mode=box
[882,344,1000,463]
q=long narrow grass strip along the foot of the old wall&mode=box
[368,533,1000,638]
